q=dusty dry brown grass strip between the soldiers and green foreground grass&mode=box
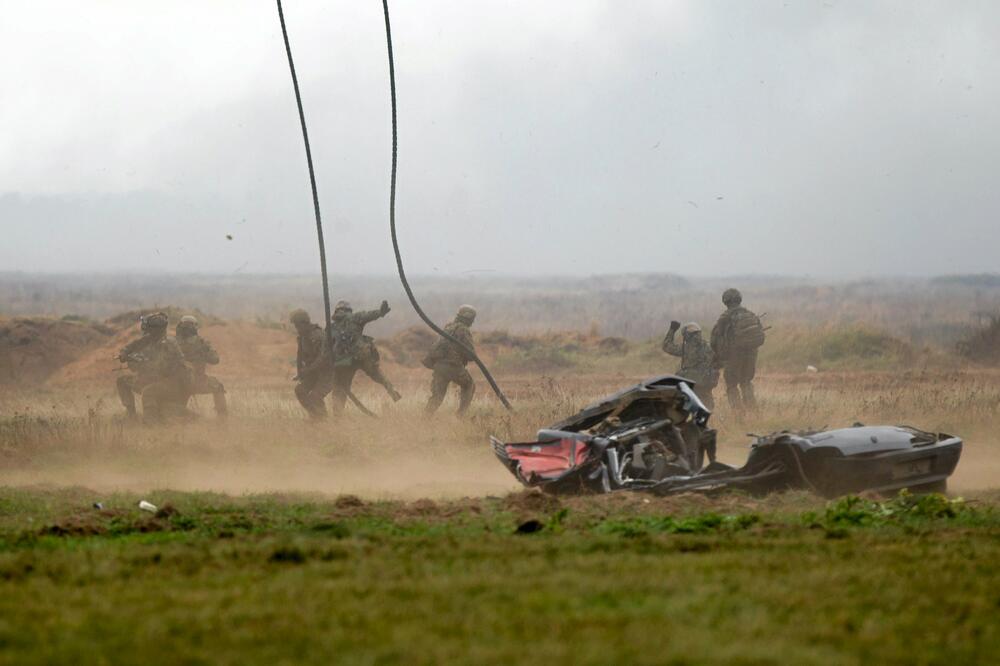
[0,370,1000,498]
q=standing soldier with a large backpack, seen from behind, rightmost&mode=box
[712,289,764,409]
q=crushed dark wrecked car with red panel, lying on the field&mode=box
[491,375,962,497]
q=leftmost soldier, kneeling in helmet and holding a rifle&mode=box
[117,312,191,422]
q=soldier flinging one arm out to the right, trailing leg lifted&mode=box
[331,301,403,408]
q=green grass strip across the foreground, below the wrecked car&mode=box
[0,489,1000,664]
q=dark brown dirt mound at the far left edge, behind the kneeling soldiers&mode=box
[0,317,114,386]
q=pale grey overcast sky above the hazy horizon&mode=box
[0,0,1000,276]
